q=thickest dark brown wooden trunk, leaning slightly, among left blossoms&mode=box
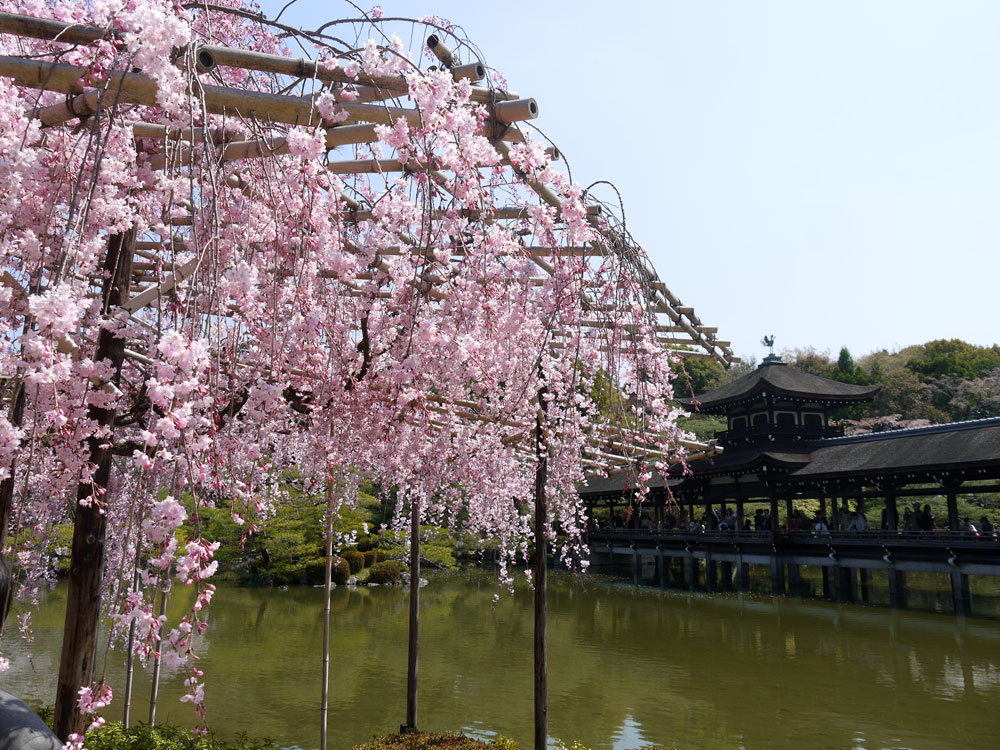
[53,227,135,741]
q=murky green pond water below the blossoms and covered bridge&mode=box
[0,572,1000,750]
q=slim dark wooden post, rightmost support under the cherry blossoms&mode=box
[534,387,549,750]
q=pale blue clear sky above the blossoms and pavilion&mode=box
[263,0,1000,359]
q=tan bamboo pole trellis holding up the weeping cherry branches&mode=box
[0,7,739,748]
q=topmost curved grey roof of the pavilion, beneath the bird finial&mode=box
[680,362,881,412]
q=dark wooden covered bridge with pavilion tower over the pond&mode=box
[580,356,1000,612]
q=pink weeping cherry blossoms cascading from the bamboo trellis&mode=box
[0,0,696,736]
